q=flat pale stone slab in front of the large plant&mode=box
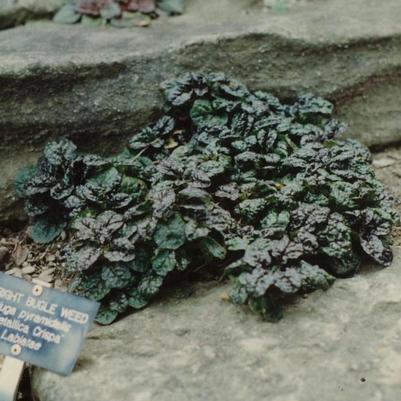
[33,248,401,401]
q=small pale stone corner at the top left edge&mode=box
[0,0,66,30]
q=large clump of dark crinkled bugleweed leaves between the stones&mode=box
[17,73,397,324]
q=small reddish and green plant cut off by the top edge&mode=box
[54,0,184,28]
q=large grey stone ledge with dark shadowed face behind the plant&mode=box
[0,0,401,221]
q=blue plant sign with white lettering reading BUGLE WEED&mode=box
[0,273,99,375]
